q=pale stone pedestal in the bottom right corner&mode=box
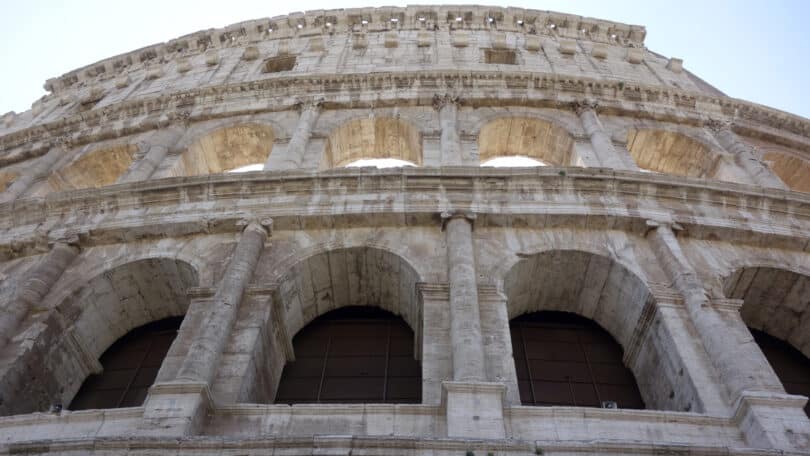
[734,391,810,451]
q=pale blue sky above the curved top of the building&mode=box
[0,0,810,118]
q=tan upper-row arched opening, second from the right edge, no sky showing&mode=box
[627,129,719,177]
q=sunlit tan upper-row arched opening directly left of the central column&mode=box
[322,117,422,168]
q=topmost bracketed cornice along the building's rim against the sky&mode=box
[45,5,646,93]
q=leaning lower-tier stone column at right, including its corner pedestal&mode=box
[648,222,810,450]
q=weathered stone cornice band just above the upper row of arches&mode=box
[0,70,810,165]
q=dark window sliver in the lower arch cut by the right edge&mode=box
[749,328,810,416]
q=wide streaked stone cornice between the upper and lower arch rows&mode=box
[0,167,810,259]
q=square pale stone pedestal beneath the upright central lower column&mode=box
[442,381,506,439]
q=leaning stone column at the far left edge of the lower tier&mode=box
[0,240,79,348]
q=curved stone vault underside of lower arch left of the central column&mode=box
[279,246,421,334]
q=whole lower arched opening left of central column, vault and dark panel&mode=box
[274,247,422,402]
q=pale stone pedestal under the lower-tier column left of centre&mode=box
[138,382,214,436]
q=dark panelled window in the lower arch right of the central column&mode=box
[509,312,644,408]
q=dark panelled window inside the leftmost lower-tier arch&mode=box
[69,317,183,410]
